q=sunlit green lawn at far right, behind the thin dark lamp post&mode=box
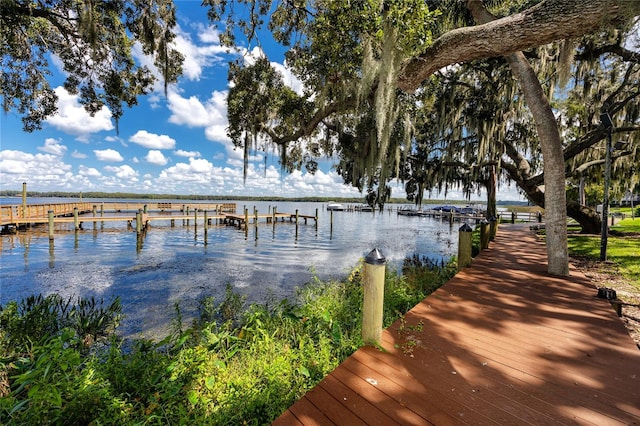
[569,218,640,290]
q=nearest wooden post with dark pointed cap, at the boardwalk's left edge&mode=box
[362,248,386,345]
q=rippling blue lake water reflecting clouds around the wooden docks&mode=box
[0,199,460,338]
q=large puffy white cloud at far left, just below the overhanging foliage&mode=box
[46,87,114,142]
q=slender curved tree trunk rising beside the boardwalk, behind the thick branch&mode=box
[467,0,569,276]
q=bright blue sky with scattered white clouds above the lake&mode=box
[0,1,521,200]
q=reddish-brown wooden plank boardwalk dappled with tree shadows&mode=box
[274,225,640,425]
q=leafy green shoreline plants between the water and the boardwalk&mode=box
[0,257,455,425]
